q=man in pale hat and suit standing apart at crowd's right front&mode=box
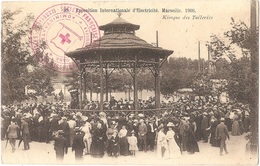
[215,118,229,156]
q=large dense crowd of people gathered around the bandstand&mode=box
[1,95,250,160]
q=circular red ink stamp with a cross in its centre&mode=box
[31,4,100,73]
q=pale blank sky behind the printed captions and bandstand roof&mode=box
[2,0,250,59]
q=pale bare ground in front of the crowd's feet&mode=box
[1,135,258,165]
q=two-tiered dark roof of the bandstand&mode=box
[66,17,173,60]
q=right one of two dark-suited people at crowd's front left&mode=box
[72,133,85,160]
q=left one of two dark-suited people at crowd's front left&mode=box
[54,130,68,161]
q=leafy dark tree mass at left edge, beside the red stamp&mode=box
[1,10,55,104]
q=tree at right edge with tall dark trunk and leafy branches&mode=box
[207,17,259,154]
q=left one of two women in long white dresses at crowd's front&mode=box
[157,125,168,159]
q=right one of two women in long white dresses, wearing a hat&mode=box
[166,122,180,158]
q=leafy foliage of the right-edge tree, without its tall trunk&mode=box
[205,18,258,103]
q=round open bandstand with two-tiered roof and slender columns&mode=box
[66,15,173,110]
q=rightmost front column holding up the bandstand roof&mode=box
[154,57,160,109]
